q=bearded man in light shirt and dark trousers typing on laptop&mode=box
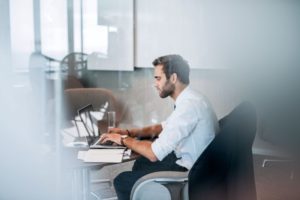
[102,55,218,200]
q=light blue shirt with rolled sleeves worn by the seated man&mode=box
[151,87,219,169]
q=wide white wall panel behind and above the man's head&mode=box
[135,0,300,69]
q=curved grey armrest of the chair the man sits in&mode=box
[130,171,188,199]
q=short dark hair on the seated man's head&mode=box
[152,54,190,85]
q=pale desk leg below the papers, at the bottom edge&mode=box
[72,168,90,200]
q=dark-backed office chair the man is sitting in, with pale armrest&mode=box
[131,102,256,200]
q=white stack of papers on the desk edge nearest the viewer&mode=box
[77,149,124,163]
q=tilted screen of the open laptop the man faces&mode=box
[77,104,99,137]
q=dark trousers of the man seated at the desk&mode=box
[114,153,187,200]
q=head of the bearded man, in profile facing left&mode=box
[152,55,190,98]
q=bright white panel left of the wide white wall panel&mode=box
[86,0,134,71]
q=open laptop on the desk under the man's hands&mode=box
[77,104,125,149]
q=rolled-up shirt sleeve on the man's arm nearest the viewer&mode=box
[151,102,199,161]
